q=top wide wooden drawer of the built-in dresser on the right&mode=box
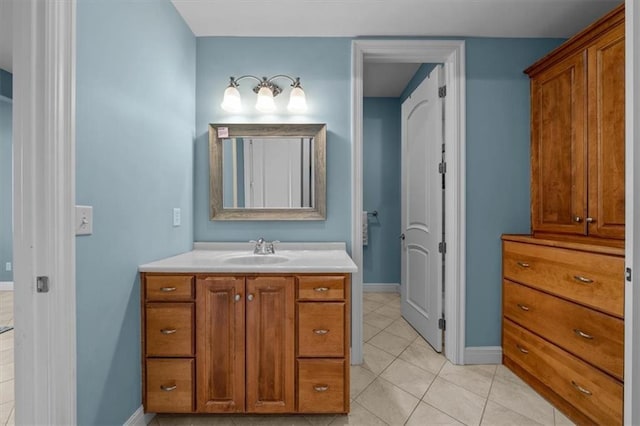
[502,241,624,318]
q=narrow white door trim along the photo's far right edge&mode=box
[624,0,640,425]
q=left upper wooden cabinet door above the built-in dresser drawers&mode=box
[531,52,587,234]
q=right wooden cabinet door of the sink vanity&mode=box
[246,276,295,413]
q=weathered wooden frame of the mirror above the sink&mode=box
[209,124,327,220]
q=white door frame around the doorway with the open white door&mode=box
[351,40,466,364]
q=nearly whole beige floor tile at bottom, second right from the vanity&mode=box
[422,377,486,425]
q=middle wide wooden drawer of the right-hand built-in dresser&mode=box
[503,280,624,380]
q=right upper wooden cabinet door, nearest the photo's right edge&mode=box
[588,23,625,239]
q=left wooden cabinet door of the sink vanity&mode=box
[196,276,245,413]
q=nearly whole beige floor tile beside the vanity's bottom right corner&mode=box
[356,379,420,425]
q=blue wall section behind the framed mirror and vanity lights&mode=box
[194,37,351,248]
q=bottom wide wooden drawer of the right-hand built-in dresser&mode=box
[502,319,623,425]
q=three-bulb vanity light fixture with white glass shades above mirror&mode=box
[220,74,307,113]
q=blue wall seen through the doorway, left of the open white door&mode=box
[362,98,402,284]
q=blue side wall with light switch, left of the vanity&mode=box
[76,0,196,425]
